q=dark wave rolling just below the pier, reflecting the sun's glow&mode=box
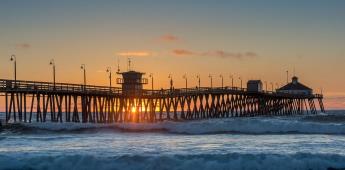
[4,116,345,135]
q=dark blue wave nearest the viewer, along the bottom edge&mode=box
[0,153,345,170]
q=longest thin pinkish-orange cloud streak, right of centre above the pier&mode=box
[172,49,258,59]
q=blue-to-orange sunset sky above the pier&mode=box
[0,0,345,108]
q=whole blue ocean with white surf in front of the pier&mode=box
[0,111,345,170]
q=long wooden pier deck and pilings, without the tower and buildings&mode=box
[0,79,325,123]
